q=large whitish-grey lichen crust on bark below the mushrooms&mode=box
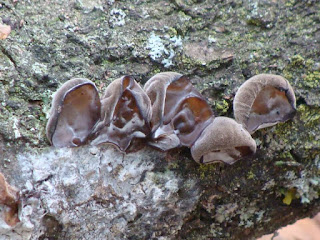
[0,147,200,240]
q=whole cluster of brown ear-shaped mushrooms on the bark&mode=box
[46,72,296,164]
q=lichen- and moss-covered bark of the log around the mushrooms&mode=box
[0,0,320,239]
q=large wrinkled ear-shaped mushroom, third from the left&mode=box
[144,72,213,151]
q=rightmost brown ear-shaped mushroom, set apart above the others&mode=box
[233,74,296,133]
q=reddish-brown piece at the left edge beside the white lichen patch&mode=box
[0,172,20,227]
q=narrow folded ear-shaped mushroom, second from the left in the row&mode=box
[90,76,151,151]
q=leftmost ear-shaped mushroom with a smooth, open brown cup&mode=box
[46,78,101,147]
